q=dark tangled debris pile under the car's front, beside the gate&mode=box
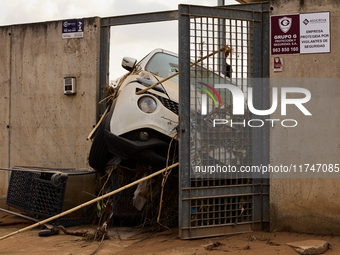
[96,165,178,231]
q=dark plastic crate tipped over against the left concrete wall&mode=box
[6,167,96,227]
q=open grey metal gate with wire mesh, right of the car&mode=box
[178,4,269,239]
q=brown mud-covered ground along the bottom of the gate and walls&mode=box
[0,212,340,255]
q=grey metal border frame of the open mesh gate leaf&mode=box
[178,3,270,239]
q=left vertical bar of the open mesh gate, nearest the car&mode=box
[178,5,190,238]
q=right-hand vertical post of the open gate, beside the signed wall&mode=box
[253,4,270,230]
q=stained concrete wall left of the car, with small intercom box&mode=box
[0,18,100,201]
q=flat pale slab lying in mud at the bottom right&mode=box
[287,240,329,255]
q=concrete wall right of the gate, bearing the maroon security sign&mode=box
[270,0,340,234]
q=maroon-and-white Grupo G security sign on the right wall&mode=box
[270,12,331,55]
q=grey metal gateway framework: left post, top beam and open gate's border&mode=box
[98,3,270,239]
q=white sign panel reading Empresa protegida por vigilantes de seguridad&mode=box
[300,12,331,53]
